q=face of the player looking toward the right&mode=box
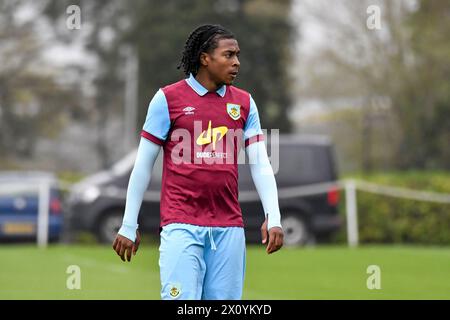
[207,39,240,85]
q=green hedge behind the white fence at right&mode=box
[335,172,450,245]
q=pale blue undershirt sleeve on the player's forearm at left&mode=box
[118,138,161,241]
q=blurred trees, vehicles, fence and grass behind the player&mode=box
[0,0,450,299]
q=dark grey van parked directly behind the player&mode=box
[69,135,341,245]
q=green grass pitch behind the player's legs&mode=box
[0,244,450,300]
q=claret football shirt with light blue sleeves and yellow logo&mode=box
[141,74,264,227]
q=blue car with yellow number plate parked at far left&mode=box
[0,172,63,241]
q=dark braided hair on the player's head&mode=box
[177,24,235,76]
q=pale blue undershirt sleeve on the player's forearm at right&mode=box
[245,141,281,230]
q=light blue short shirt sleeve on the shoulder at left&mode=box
[142,89,170,141]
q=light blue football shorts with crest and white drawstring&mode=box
[159,223,245,300]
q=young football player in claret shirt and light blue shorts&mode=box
[113,25,283,300]
